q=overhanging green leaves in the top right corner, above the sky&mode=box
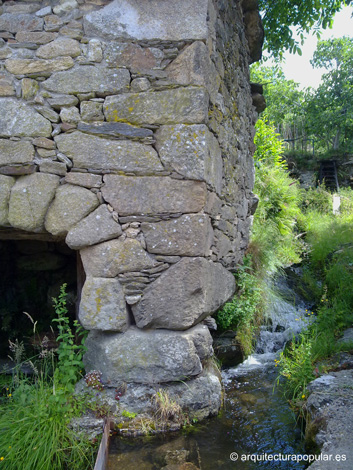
[259,0,353,57]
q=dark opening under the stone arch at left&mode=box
[0,240,78,357]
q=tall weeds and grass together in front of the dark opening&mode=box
[0,285,96,470]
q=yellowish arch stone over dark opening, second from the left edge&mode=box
[9,173,60,232]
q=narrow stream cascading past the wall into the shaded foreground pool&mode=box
[108,278,312,470]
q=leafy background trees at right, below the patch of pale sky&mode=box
[251,37,353,153]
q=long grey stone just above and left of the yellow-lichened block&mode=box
[43,65,130,94]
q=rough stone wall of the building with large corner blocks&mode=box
[0,0,261,415]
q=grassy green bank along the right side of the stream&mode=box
[278,188,353,400]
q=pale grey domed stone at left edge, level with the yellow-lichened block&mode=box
[0,98,52,137]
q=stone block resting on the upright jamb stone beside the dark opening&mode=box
[80,238,155,277]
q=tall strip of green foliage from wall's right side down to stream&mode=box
[216,120,302,355]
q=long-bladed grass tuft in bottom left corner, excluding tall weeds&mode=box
[0,378,96,470]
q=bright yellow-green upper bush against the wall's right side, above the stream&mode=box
[250,120,301,272]
